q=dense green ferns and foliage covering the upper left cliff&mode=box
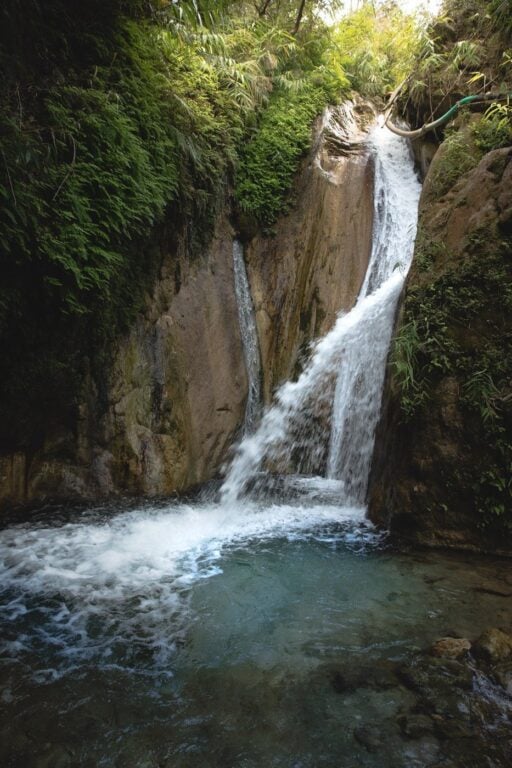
[0,0,352,448]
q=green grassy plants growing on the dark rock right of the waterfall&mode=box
[391,232,512,532]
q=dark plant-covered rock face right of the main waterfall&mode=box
[369,138,512,553]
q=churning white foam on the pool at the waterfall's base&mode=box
[0,498,370,680]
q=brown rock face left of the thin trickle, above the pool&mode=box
[0,218,247,502]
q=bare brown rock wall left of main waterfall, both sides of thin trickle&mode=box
[0,106,373,510]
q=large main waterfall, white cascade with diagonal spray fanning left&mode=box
[222,121,421,505]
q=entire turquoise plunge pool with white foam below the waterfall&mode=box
[0,488,512,768]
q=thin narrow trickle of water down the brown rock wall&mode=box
[233,240,262,435]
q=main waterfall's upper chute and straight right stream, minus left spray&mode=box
[327,123,420,504]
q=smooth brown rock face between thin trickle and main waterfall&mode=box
[246,103,374,403]
